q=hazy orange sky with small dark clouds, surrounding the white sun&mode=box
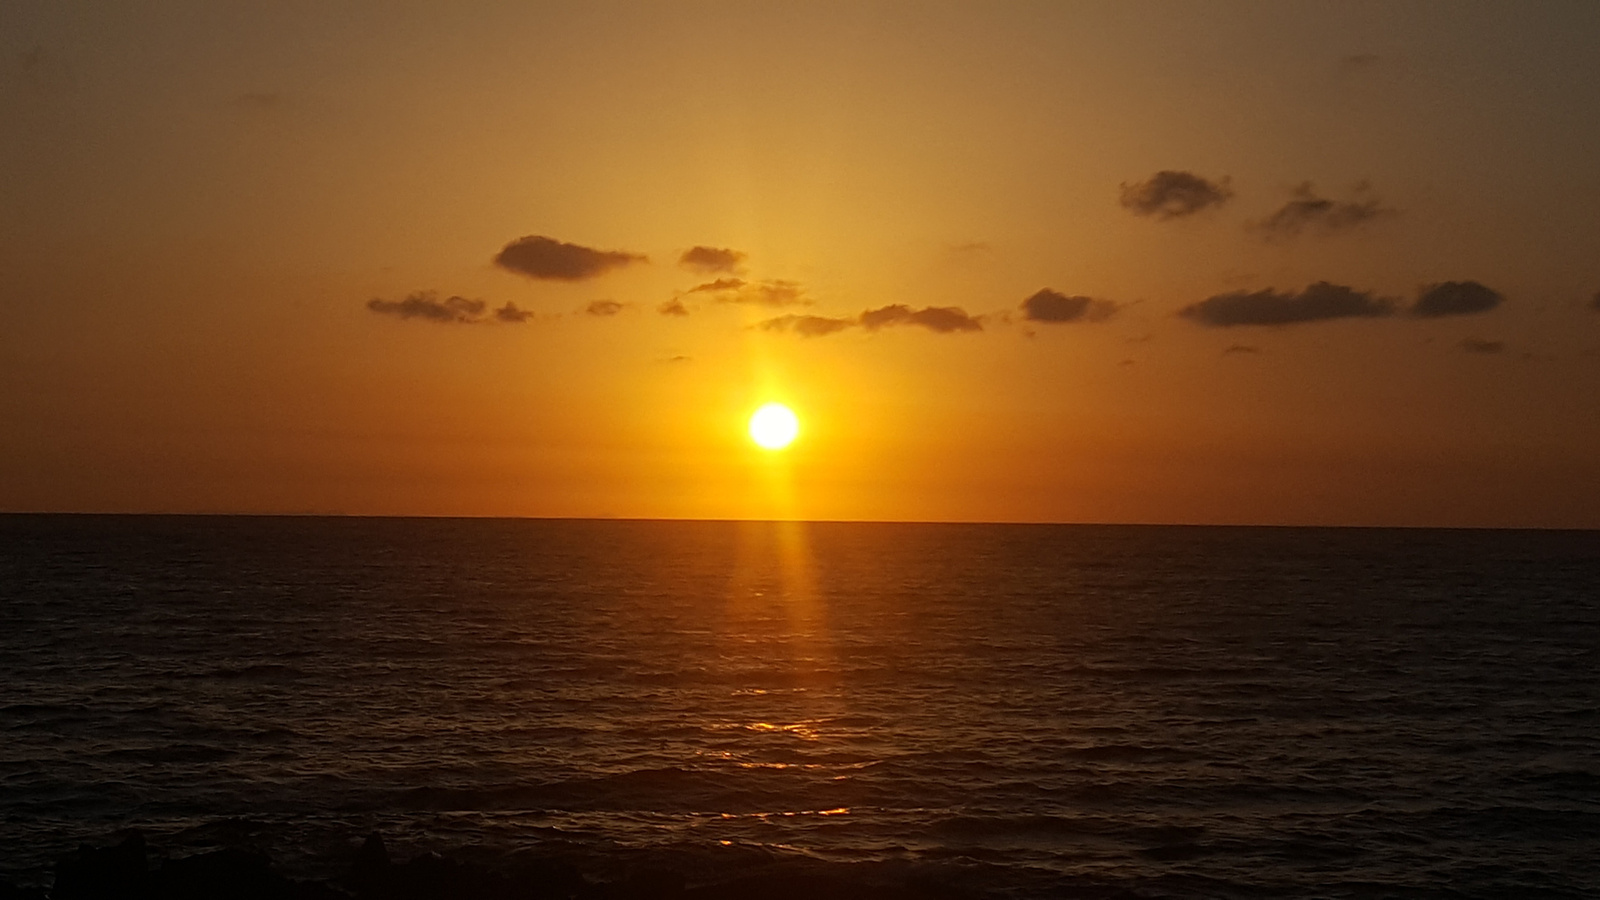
[0,0,1600,527]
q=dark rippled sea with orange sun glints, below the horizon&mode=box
[0,516,1600,898]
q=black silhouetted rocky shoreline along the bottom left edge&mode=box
[0,834,968,900]
